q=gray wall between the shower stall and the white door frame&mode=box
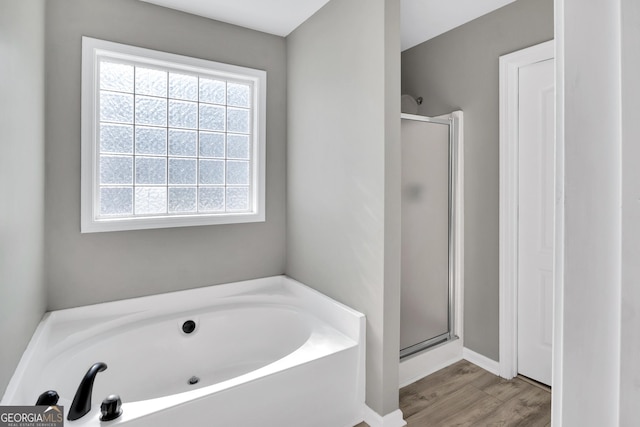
[402,0,553,360]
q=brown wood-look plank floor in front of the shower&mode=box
[356,360,551,427]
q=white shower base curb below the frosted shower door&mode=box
[399,339,462,388]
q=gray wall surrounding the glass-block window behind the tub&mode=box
[45,0,286,309]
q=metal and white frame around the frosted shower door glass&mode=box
[400,111,464,359]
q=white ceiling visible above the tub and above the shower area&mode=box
[142,0,515,50]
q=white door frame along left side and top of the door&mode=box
[499,40,555,379]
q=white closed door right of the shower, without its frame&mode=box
[517,55,555,385]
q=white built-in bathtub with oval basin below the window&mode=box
[2,276,365,427]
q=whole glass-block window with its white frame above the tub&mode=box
[81,37,266,233]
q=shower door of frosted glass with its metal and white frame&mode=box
[400,108,462,358]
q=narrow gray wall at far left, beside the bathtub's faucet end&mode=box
[0,0,46,394]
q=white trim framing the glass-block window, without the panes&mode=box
[80,37,267,233]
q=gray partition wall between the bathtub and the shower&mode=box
[286,0,400,415]
